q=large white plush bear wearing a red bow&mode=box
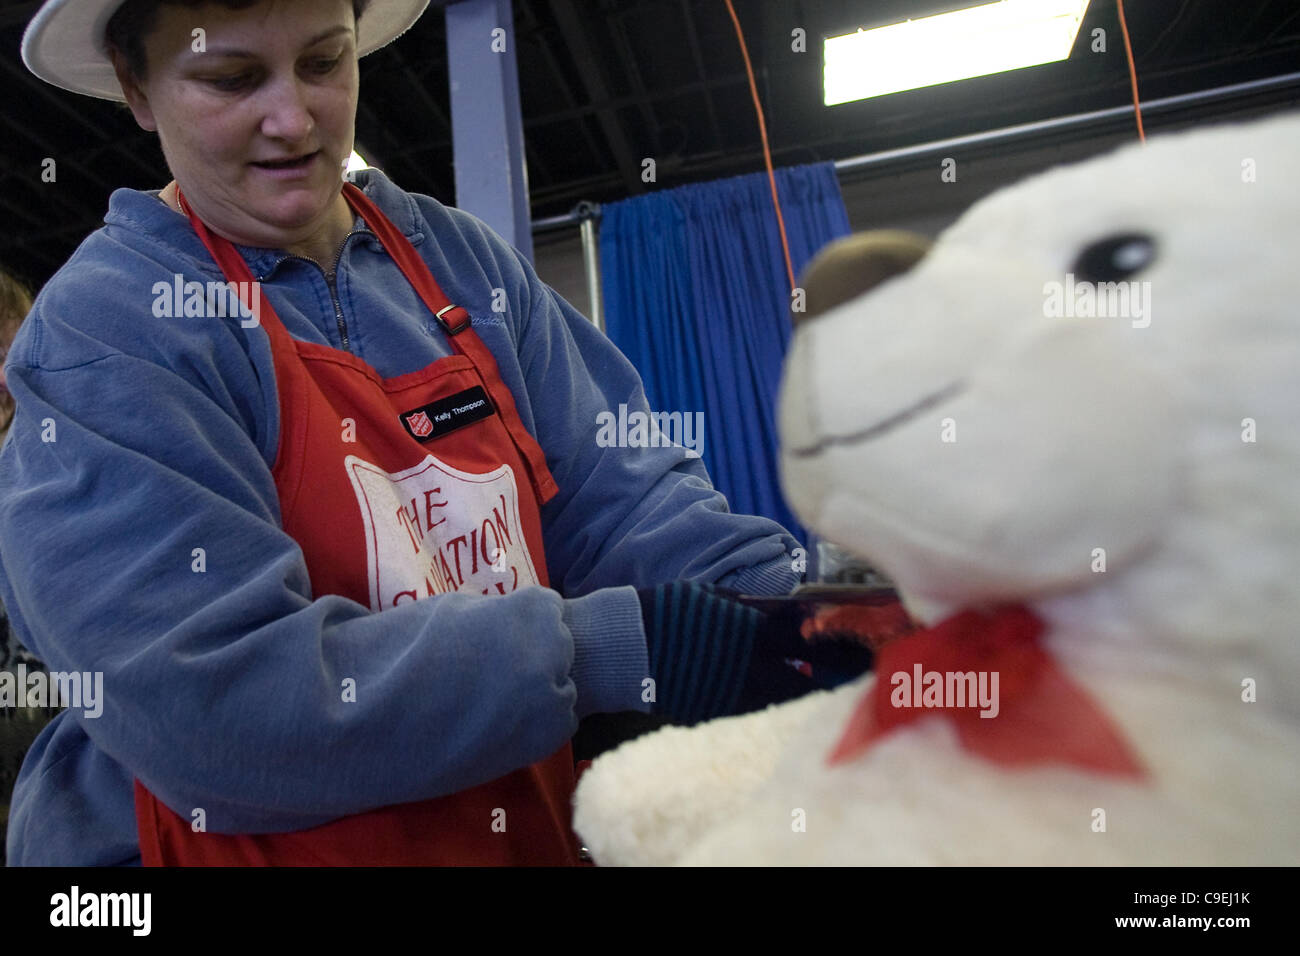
[575,114,1300,865]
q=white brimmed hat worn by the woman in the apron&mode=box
[22,0,429,103]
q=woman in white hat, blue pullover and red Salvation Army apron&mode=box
[0,0,811,864]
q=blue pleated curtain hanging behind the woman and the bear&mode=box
[601,163,849,540]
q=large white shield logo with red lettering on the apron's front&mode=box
[343,455,540,611]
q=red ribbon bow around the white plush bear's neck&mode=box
[827,606,1145,778]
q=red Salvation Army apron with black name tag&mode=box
[135,183,577,866]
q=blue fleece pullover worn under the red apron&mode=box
[0,170,796,865]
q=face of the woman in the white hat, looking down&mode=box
[114,0,358,248]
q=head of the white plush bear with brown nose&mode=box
[780,114,1300,714]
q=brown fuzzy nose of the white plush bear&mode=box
[794,229,931,323]
